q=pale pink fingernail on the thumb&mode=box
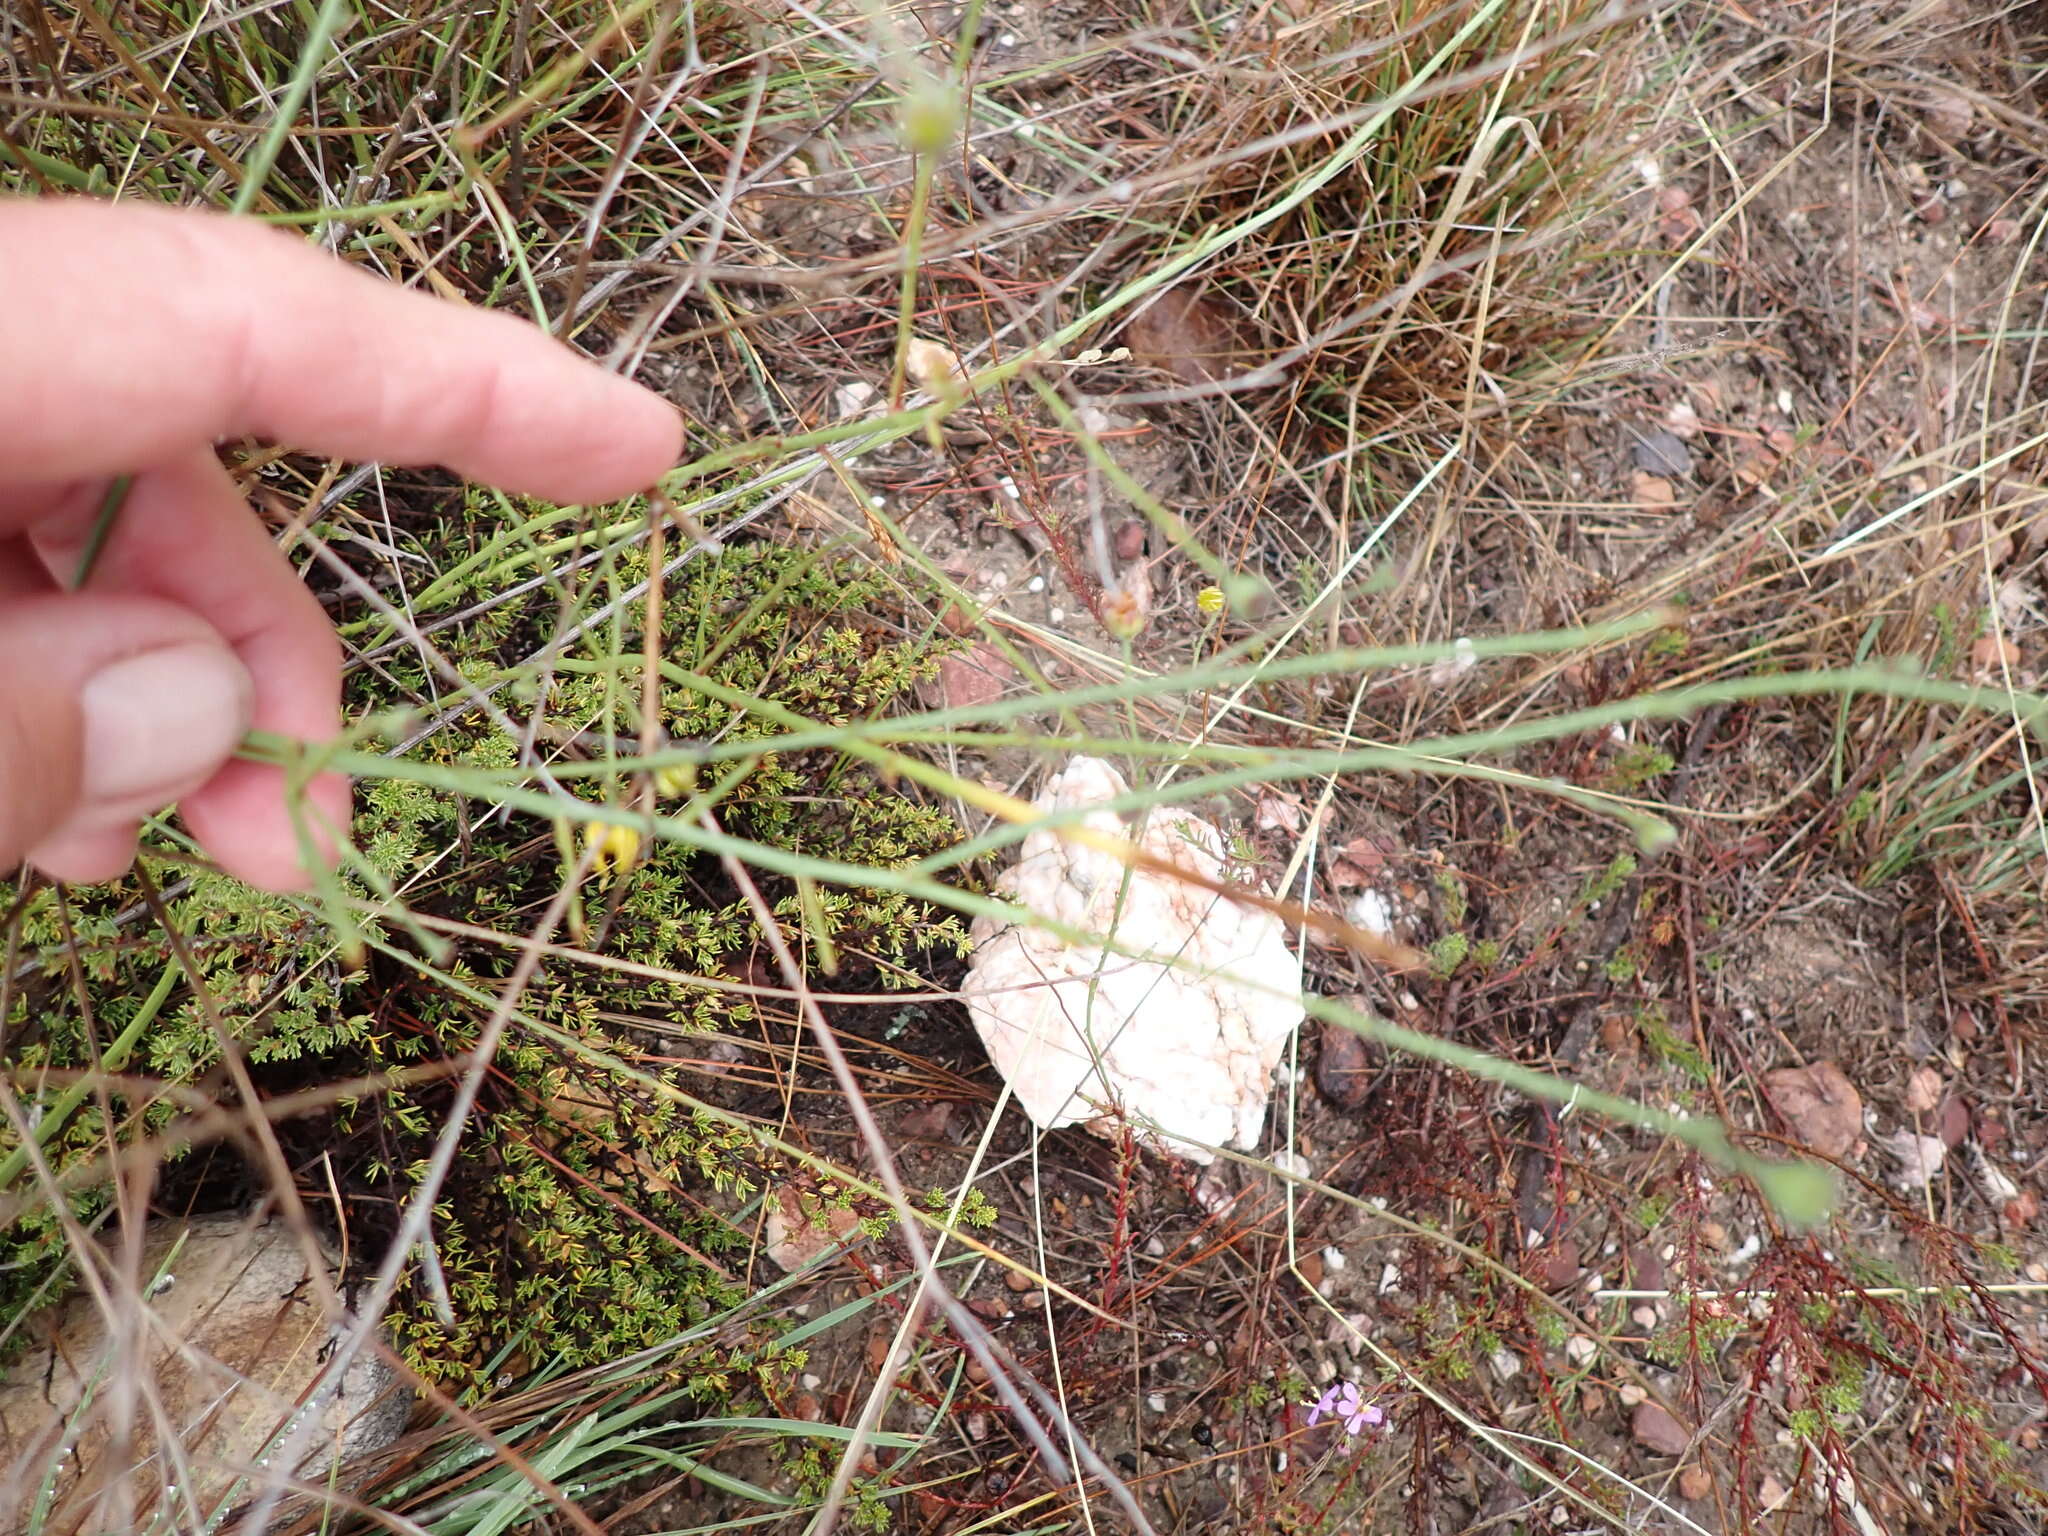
[80,643,256,809]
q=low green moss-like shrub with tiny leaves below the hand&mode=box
[0,536,966,1411]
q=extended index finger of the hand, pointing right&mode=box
[0,199,682,502]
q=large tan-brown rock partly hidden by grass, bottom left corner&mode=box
[0,1217,412,1536]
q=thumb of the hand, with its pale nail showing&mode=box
[0,594,254,881]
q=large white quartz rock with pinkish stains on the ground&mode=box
[963,758,1303,1163]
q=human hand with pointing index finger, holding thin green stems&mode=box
[0,199,682,891]
